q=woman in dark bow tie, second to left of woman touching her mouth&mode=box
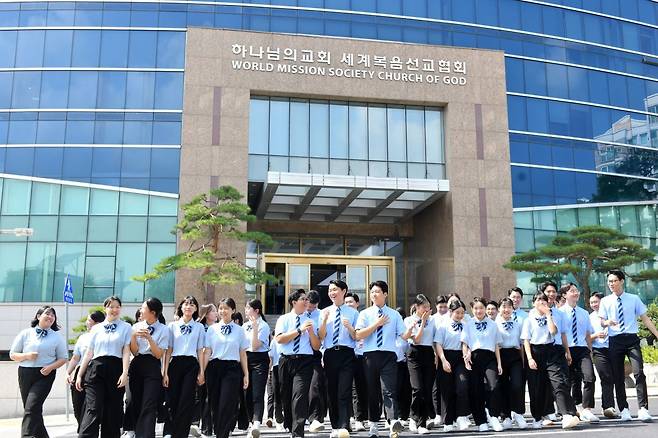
[462,297,503,432]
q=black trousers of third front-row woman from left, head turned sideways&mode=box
[124,354,162,438]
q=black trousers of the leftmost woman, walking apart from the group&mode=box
[18,367,57,438]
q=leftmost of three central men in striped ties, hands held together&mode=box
[274,290,320,437]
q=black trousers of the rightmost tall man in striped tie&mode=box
[609,334,649,410]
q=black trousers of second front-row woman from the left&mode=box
[78,356,125,438]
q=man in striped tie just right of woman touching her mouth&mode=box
[560,283,599,423]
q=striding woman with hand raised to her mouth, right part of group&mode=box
[521,290,579,429]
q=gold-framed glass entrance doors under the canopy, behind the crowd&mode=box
[260,254,395,315]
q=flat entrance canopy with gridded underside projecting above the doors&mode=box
[256,172,450,224]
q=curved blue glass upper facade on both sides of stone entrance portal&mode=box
[0,0,658,300]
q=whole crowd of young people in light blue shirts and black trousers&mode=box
[10,271,658,438]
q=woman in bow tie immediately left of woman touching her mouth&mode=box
[496,298,527,429]
